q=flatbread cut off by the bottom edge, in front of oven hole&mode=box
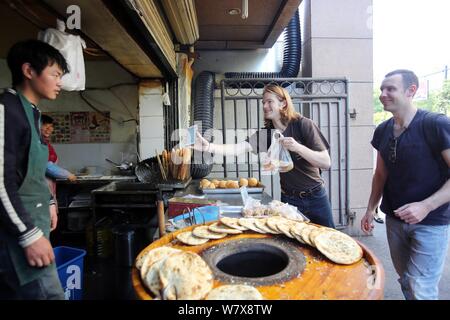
[205,284,264,300]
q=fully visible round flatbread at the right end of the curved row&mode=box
[314,231,363,264]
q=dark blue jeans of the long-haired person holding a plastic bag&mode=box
[281,187,335,228]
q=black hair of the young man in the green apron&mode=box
[7,40,69,87]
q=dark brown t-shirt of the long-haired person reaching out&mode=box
[248,116,329,192]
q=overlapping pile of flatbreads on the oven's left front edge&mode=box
[136,246,213,300]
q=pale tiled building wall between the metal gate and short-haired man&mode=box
[301,0,374,235]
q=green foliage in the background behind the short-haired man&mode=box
[373,80,450,125]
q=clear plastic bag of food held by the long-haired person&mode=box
[261,130,294,175]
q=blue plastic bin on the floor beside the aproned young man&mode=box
[53,247,86,300]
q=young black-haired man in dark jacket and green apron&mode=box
[0,40,68,299]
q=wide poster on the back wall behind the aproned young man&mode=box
[46,112,111,144]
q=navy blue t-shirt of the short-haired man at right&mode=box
[371,109,450,225]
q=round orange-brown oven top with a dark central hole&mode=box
[132,222,384,300]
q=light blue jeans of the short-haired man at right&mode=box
[386,215,450,300]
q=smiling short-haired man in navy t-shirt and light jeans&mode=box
[361,70,450,300]
